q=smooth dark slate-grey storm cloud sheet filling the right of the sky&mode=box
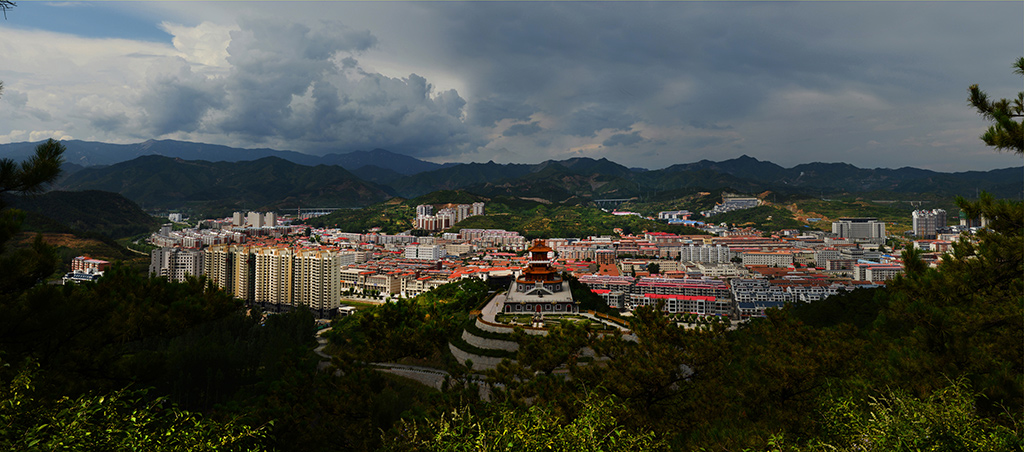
[417,2,1021,164]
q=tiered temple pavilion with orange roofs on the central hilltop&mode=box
[501,240,580,314]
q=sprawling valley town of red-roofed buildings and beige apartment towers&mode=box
[142,195,913,319]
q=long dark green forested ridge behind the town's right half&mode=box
[380,156,1024,198]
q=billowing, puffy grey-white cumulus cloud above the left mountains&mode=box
[130,20,483,156]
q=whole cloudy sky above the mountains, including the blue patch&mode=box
[0,1,1024,171]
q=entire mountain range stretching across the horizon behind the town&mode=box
[0,140,1024,212]
